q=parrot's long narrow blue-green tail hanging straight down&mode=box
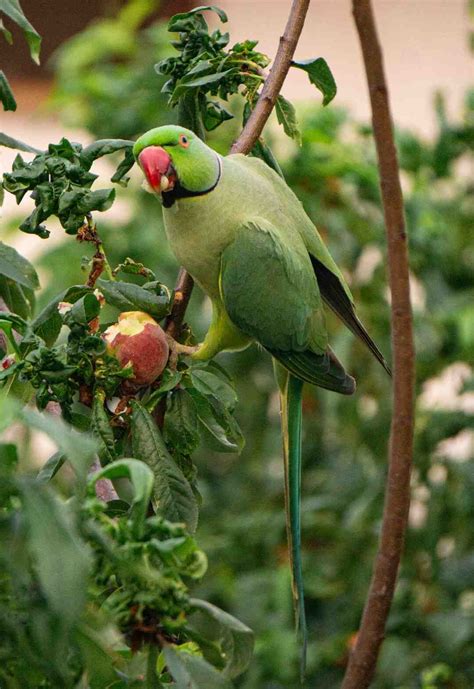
[277,365,308,678]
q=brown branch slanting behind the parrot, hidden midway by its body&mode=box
[166,0,310,337]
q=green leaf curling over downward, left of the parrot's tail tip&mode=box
[190,598,254,679]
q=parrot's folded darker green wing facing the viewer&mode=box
[220,217,355,394]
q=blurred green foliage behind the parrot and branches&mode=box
[0,3,474,689]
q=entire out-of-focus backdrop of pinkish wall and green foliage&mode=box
[0,0,474,689]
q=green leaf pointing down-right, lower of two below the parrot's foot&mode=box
[187,388,245,452]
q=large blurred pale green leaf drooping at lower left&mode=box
[21,481,92,628]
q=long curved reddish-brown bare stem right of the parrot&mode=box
[342,0,415,689]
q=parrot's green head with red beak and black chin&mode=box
[133,125,221,207]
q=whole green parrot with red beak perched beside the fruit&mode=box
[134,125,390,662]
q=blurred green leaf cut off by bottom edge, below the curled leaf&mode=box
[163,646,232,689]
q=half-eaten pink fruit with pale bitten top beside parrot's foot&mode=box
[104,311,169,385]
